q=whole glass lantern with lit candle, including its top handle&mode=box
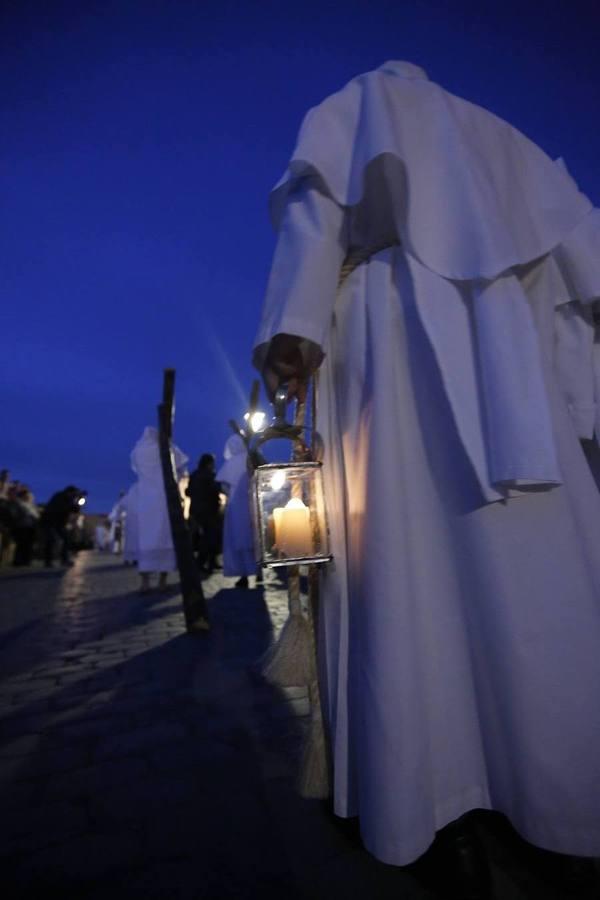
[250,390,332,568]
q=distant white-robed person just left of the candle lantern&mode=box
[216,434,257,588]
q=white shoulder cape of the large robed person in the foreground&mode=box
[271,60,592,280]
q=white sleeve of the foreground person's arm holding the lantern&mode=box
[255,179,346,359]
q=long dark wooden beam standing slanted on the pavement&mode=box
[158,369,210,633]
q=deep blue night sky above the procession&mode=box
[0,0,600,510]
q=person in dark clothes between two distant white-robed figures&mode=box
[186,453,223,574]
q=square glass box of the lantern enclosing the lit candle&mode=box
[252,462,331,566]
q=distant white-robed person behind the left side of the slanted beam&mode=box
[131,426,188,592]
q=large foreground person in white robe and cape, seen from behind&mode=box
[254,61,600,884]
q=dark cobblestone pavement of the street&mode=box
[0,552,586,900]
